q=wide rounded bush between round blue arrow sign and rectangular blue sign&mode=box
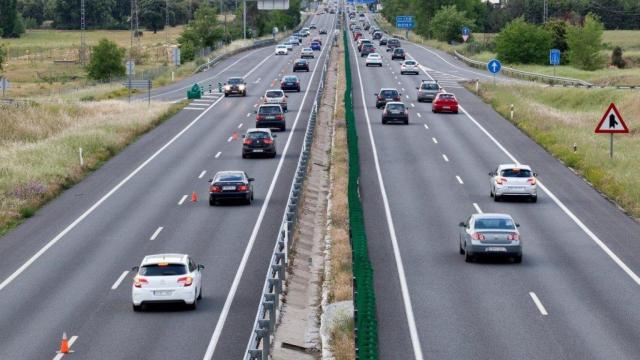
[496,17,552,64]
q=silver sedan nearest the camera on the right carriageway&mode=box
[459,214,522,263]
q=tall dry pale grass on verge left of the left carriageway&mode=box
[0,101,177,233]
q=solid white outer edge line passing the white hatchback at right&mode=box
[459,106,640,285]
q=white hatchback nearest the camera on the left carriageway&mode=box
[131,254,204,311]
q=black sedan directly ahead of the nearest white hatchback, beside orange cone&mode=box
[209,171,254,206]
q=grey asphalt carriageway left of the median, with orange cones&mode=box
[0,11,335,360]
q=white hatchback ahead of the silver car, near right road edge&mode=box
[489,164,538,202]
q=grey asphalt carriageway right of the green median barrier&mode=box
[350,16,640,360]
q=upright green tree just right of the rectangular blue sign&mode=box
[567,14,604,71]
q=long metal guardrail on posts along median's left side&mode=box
[244,21,334,360]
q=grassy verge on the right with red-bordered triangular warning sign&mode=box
[469,84,640,219]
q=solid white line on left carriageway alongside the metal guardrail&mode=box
[203,12,335,360]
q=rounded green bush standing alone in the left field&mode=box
[87,39,125,81]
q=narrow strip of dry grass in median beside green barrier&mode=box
[328,32,355,360]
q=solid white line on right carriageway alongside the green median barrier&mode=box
[351,29,423,360]
